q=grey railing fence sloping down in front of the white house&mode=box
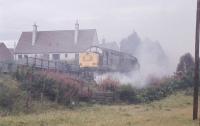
[0,57,94,81]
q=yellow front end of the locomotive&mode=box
[79,52,99,68]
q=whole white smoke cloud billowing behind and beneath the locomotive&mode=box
[96,33,172,88]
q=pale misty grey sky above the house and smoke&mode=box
[0,0,196,67]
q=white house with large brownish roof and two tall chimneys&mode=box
[15,22,98,62]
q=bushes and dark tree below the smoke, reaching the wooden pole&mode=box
[103,53,194,103]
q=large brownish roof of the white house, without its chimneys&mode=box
[15,29,98,53]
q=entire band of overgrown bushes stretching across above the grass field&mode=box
[0,54,193,115]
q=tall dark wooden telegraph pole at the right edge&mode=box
[193,0,200,120]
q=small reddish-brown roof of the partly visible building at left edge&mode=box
[0,42,13,62]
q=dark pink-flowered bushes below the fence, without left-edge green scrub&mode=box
[15,68,83,104]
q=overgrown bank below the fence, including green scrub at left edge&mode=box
[0,68,87,116]
